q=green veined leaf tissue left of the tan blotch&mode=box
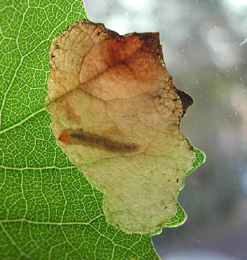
[0,0,158,260]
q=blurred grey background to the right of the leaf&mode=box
[85,0,247,260]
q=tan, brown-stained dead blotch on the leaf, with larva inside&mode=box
[46,20,195,233]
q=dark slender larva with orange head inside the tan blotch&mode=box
[58,129,140,153]
